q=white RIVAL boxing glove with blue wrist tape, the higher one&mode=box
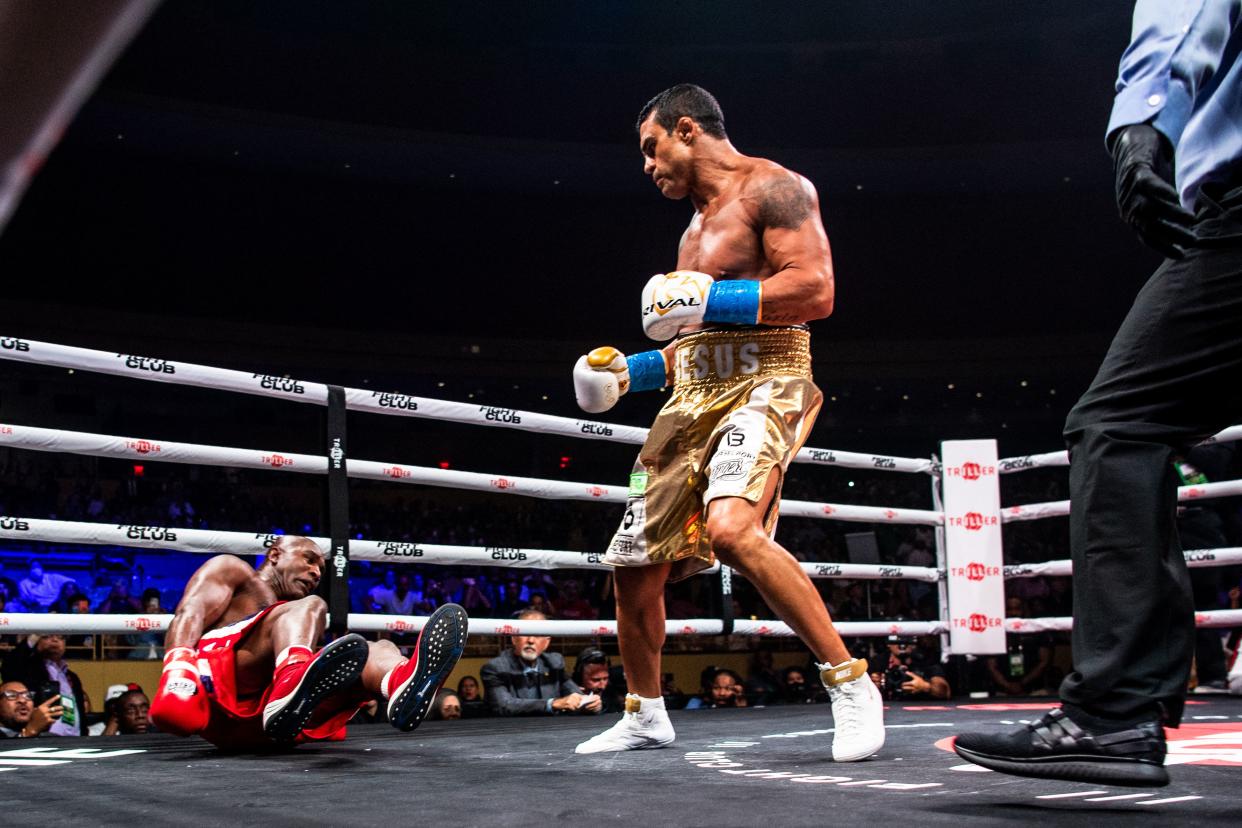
[642,271,763,341]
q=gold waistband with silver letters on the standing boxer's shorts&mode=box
[673,328,811,391]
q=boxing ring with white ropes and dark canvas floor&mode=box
[0,338,1242,826]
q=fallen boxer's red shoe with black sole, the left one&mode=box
[263,633,370,742]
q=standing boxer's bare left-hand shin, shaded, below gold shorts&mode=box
[614,564,672,699]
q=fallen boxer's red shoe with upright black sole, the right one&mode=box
[388,603,469,731]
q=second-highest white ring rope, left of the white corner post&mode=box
[0,423,944,525]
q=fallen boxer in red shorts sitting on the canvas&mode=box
[150,536,467,750]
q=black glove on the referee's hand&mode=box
[1113,124,1195,258]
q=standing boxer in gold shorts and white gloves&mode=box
[574,84,884,761]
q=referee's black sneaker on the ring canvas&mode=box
[953,708,1169,788]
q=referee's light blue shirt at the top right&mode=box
[1108,0,1242,210]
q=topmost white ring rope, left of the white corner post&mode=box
[0,336,933,473]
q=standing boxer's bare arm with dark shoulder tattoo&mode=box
[750,170,835,325]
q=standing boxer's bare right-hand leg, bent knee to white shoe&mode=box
[710,472,850,664]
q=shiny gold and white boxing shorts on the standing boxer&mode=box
[604,328,823,581]
